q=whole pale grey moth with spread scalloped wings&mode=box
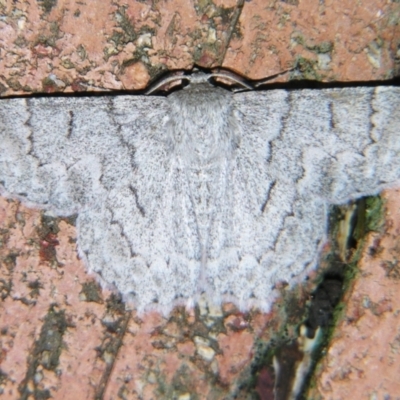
[0,73,400,313]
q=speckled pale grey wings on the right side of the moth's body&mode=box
[219,87,400,306]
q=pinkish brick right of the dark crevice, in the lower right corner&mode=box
[309,190,400,400]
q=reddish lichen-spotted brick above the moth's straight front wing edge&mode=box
[0,0,400,95]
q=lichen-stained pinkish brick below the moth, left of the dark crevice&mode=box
[0,198,288,399]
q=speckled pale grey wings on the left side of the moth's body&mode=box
[0,96,198,308]
